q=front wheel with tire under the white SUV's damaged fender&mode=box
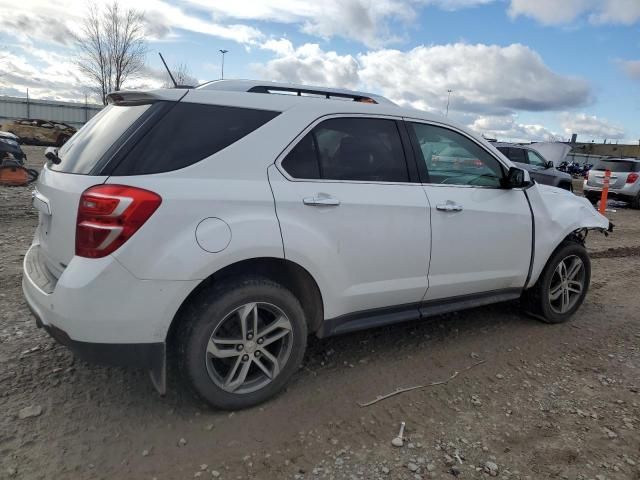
[522,241,591,323]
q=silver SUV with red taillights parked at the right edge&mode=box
[584,158,640,209]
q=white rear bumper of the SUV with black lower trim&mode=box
[22,244,193,371]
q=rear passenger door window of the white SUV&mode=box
[282,118,409,182]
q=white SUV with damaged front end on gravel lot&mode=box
[23,81,610,409]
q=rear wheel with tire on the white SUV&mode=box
[178,277,307,410]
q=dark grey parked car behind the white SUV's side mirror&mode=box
[494,143,573,192]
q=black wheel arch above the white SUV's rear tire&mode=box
[166,257,324,348]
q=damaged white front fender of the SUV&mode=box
[525,184,613,288]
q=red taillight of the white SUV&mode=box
[76,185,162,258]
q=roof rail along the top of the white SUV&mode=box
[196,80,396,105]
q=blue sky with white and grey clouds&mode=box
[0,0,640,143]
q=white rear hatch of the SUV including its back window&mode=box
[33,103,158,278]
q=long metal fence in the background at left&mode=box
[0,96,102,127]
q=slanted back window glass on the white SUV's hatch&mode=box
[49,104,151,175]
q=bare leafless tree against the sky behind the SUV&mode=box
[76,1,147,105]
